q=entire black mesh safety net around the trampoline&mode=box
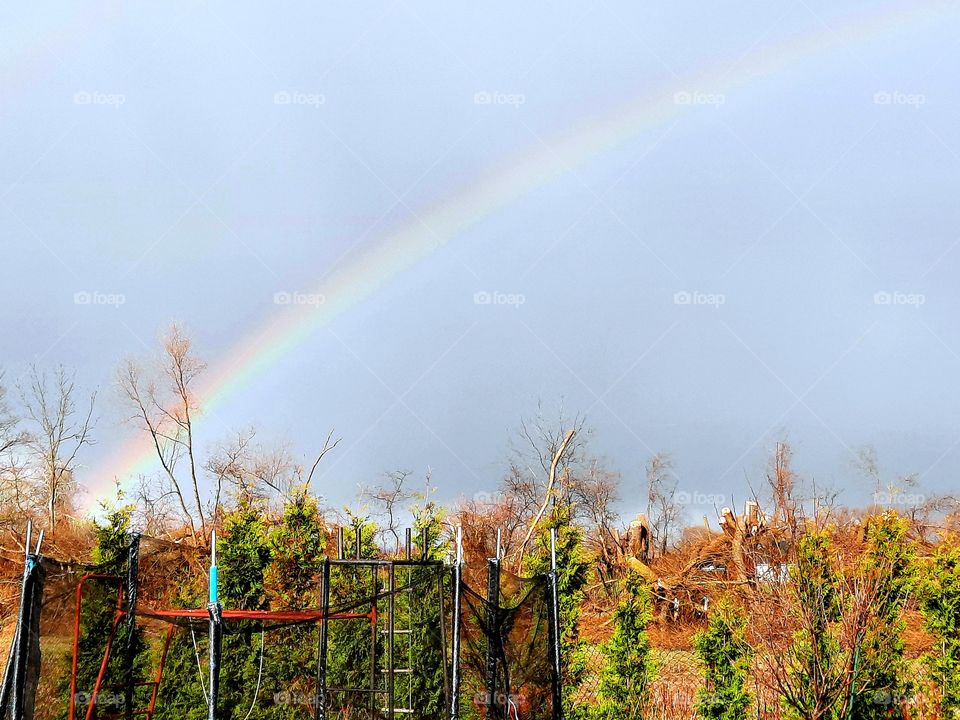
[0,537,558,720]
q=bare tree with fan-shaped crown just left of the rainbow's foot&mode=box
[20,366,97,536]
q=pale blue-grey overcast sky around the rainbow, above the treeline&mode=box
[0,0,960,516]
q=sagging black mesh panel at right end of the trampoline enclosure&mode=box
[460,571,554,720]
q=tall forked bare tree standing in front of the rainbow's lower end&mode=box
[118,325,207,542]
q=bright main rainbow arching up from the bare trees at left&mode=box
[87,1,946,507]
